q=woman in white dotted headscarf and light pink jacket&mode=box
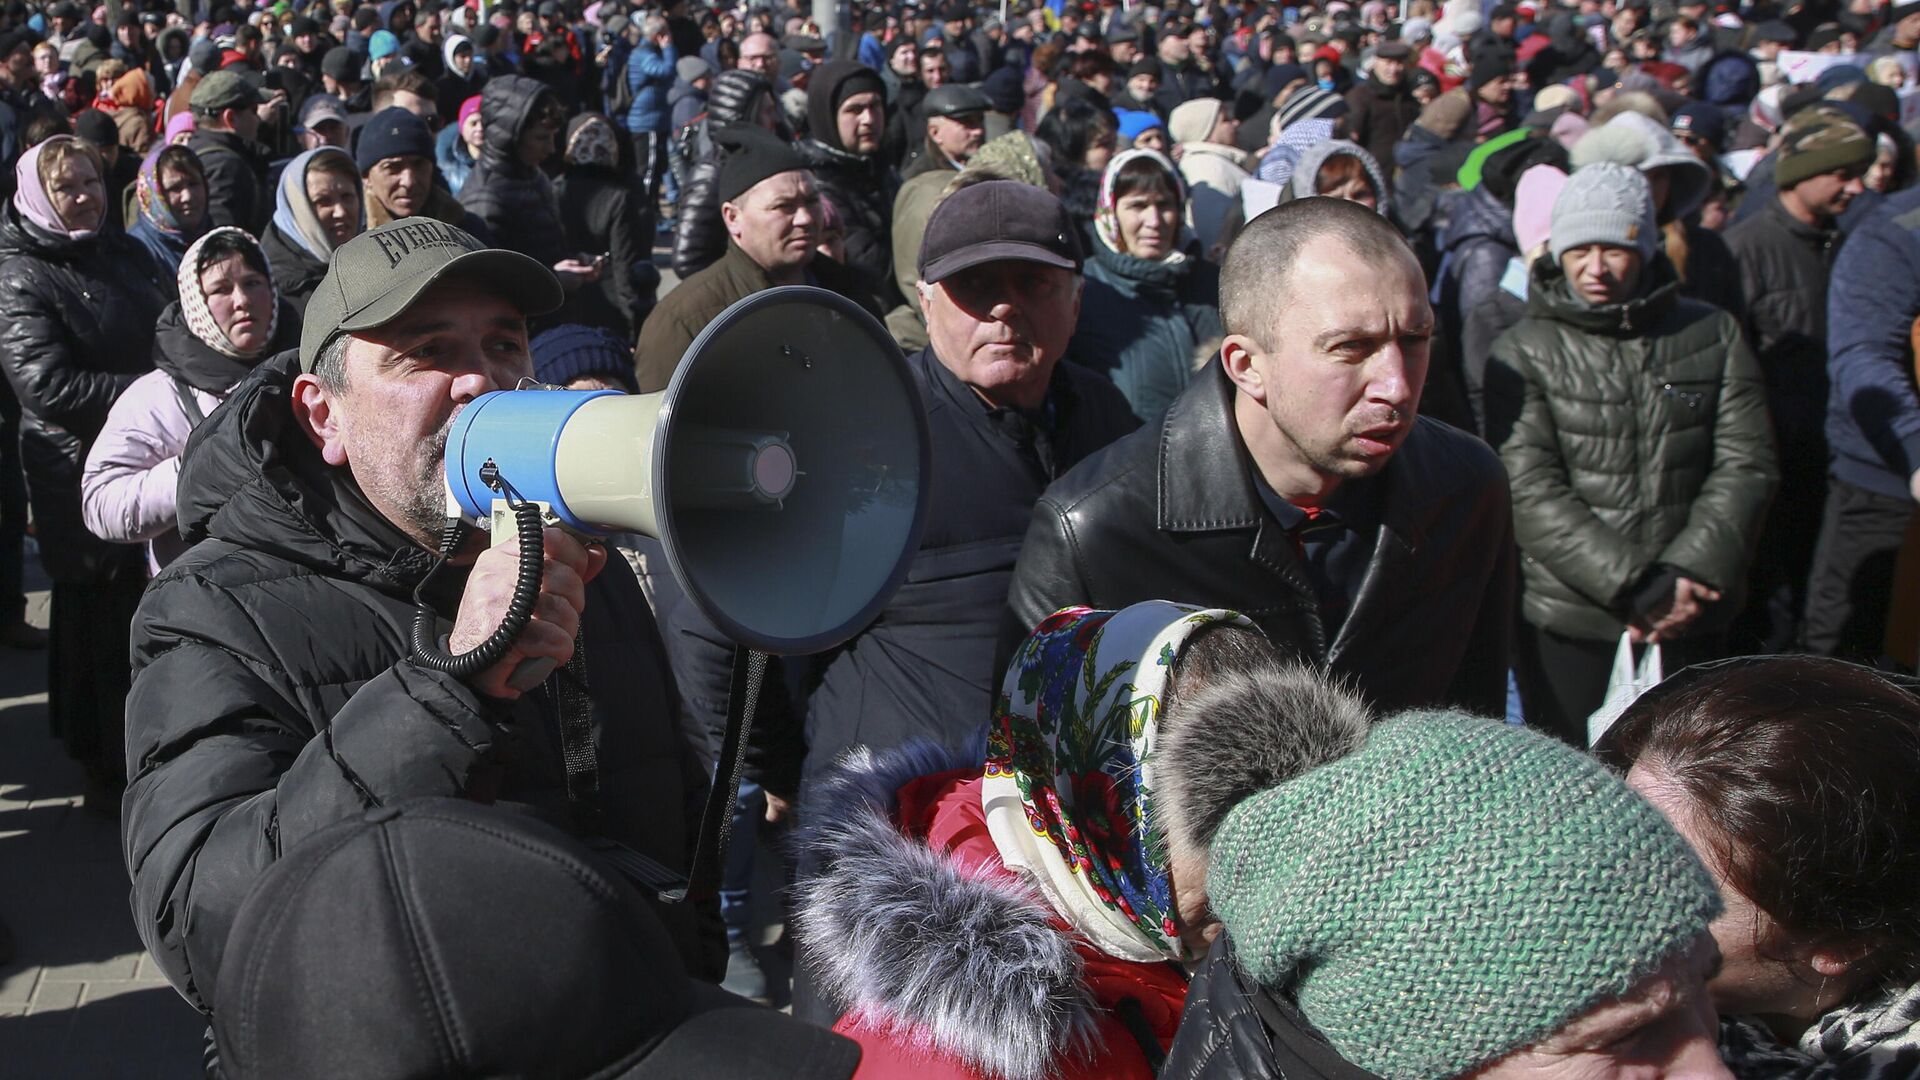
[81,227,300,573]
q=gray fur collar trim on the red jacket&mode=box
[795,742,1098,1080]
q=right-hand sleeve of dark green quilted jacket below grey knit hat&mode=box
[1659,315,1780,588]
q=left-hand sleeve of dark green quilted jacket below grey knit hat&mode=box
[1486,332,1645,611]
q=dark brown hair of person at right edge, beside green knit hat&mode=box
[1596,657,1920,982]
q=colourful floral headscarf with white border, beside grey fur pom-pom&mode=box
[981,600,1254,963]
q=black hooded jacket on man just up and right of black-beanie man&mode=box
[801,60,900,307]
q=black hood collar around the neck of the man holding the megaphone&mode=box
[179,352,453,611]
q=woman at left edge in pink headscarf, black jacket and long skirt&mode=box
[0,135,167,815]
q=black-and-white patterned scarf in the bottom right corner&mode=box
[1720,986,1920,1080]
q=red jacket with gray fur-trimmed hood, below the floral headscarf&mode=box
[795,744,1187,1080]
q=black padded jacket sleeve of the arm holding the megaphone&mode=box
[123,575,503,1011]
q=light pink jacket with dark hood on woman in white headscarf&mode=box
[81,298,300,571]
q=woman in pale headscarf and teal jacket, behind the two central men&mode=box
[1068,150,1223,423]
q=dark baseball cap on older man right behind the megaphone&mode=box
[920,181,1081,282]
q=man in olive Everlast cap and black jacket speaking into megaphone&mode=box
[125,217,726,1011]
